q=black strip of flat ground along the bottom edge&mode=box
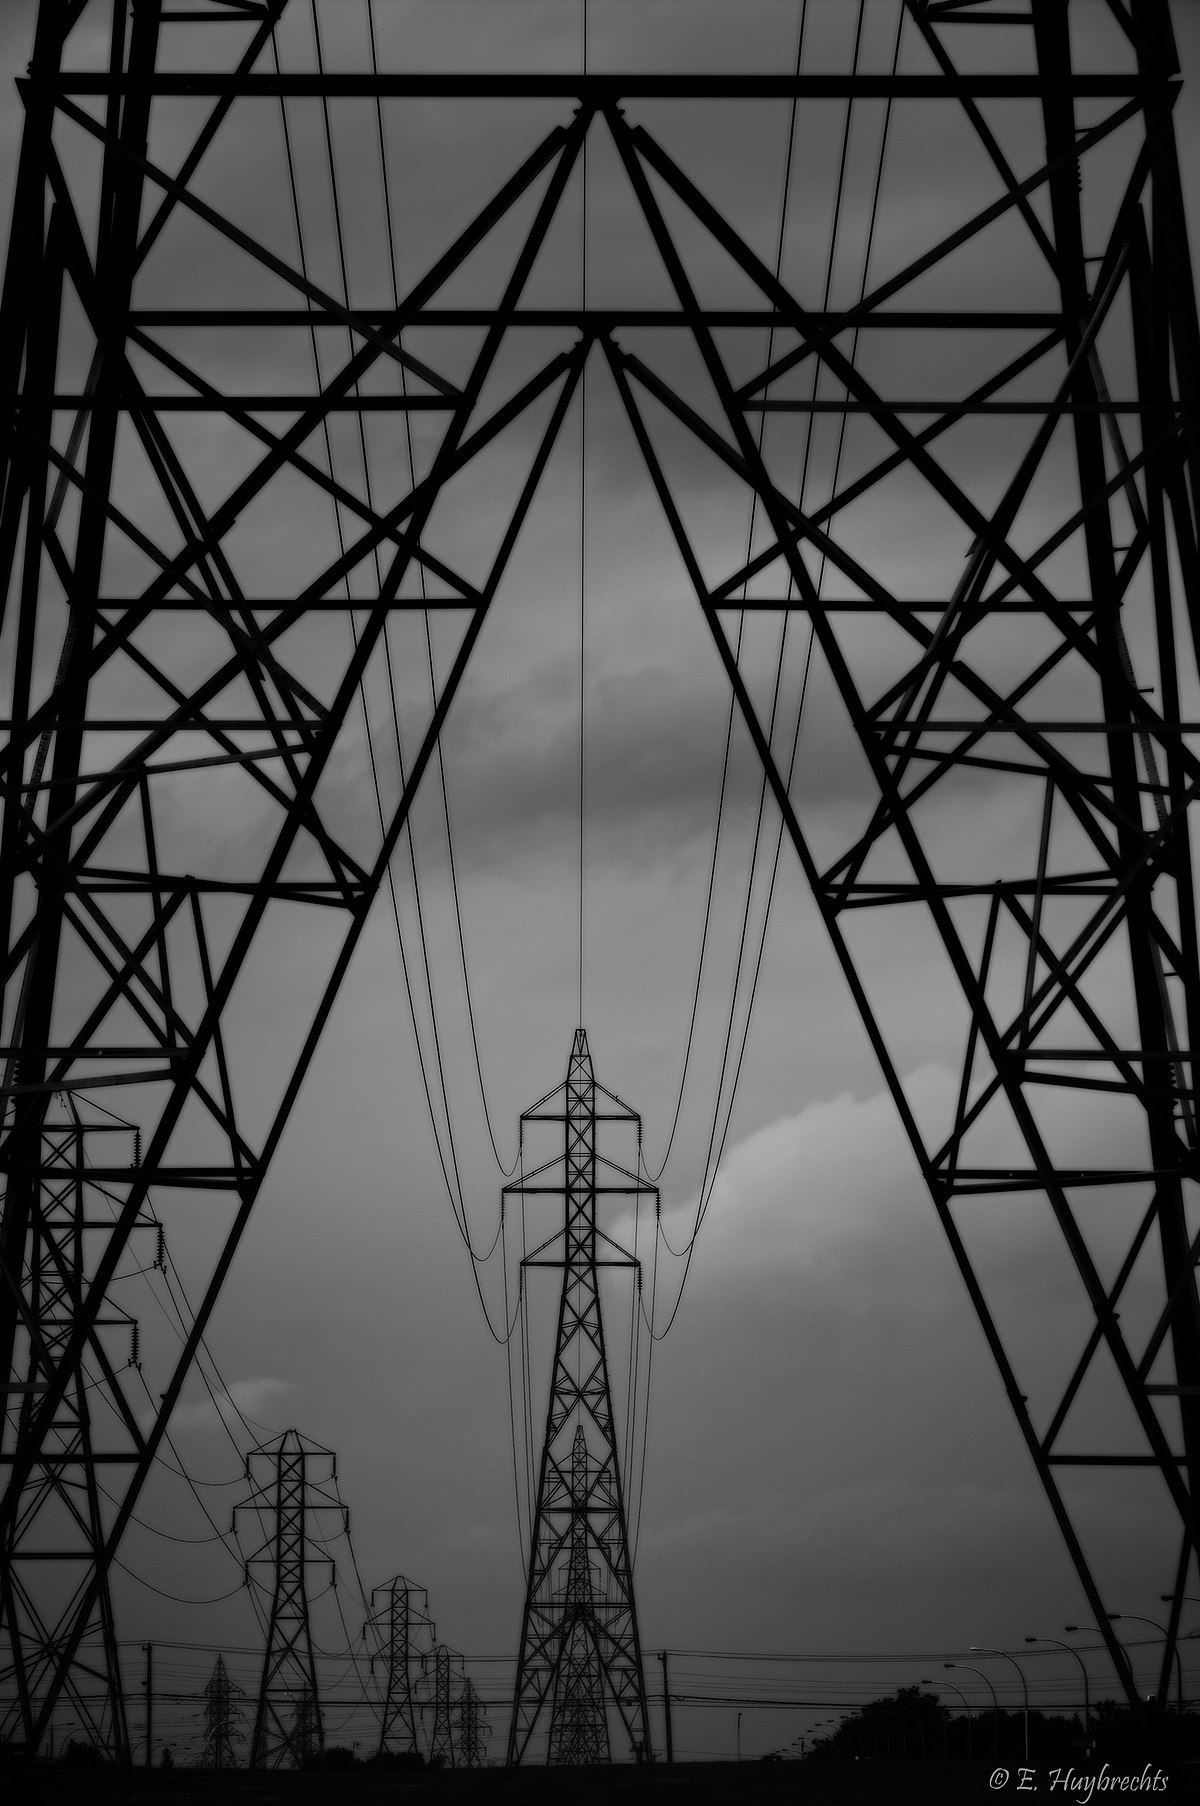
[0,1761,1200,1806]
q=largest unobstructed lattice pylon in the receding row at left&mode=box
[237,1430,349,1768]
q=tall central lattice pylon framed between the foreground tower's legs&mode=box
[504,1028,654,1763]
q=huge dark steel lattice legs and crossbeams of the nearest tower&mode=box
[0,0,1200,1746]
